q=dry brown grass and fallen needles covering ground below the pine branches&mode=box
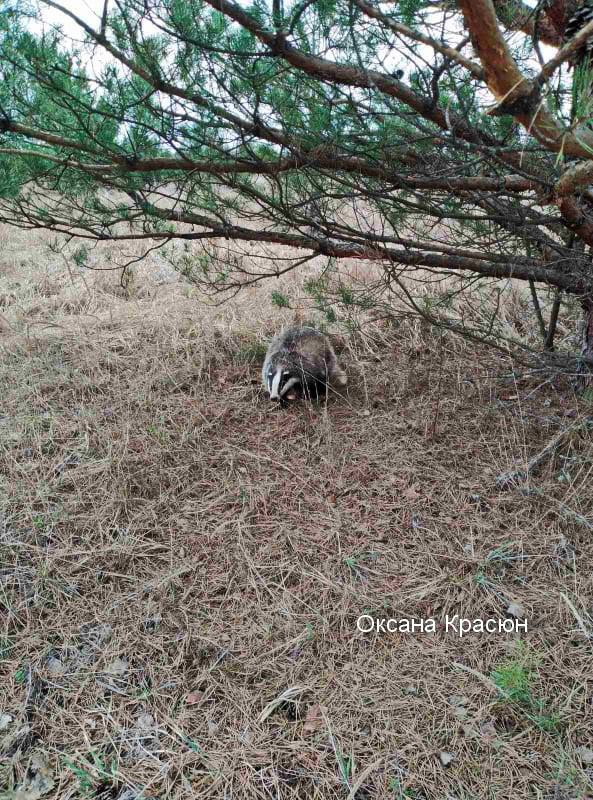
[0,223,593,800]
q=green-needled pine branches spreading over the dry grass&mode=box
[0,0,593,362]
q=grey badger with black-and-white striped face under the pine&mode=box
[262,327,347,403]
